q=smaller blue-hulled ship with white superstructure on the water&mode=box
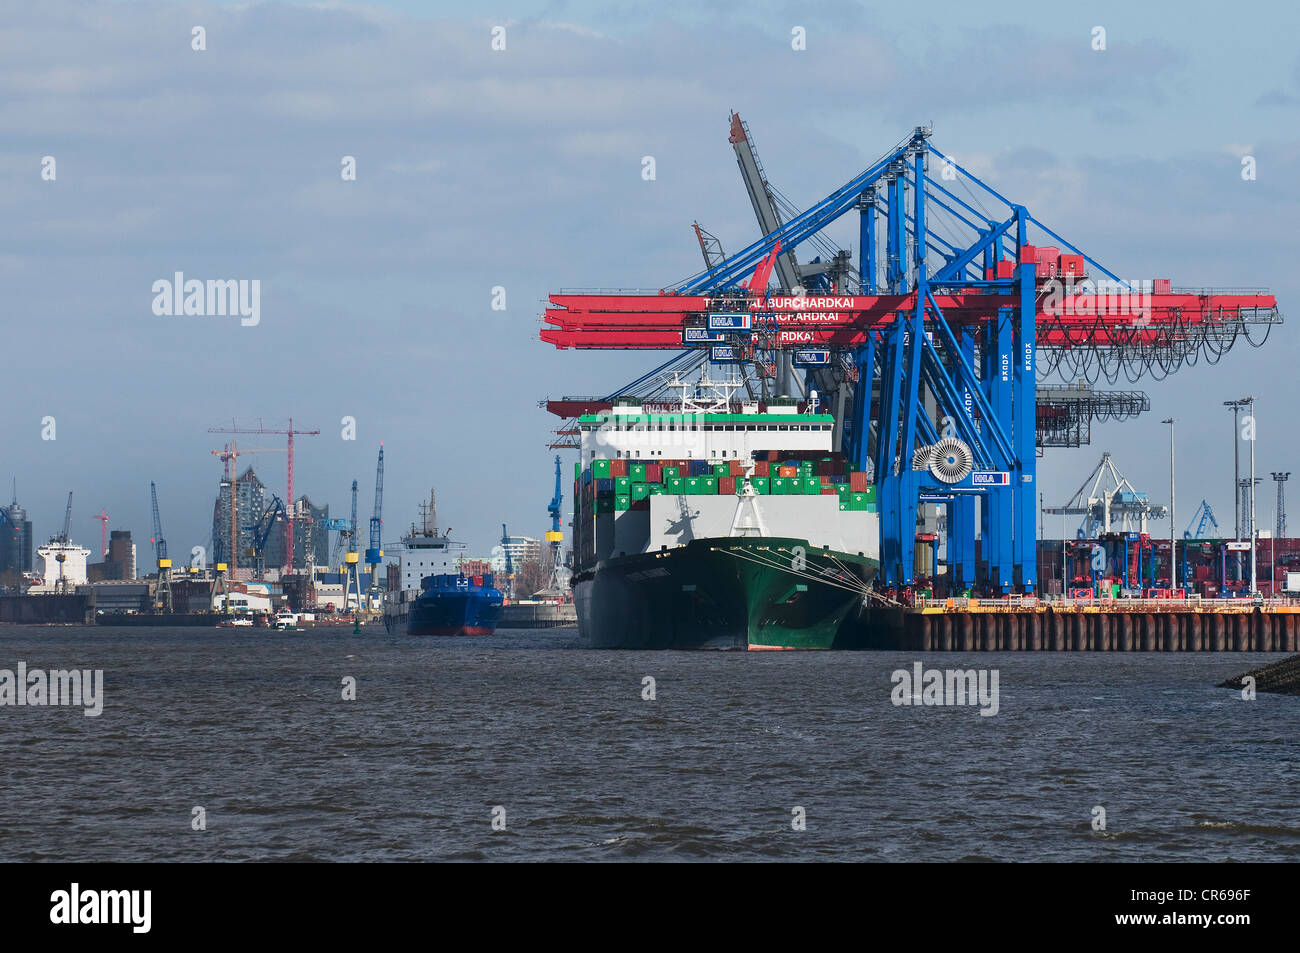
[384,490,502,636]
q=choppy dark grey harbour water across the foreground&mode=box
[0,628,1300,861]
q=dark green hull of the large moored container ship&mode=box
[573,537,878,651]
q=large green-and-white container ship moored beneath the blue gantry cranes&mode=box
[572,376,880,651]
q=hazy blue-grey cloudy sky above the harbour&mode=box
[0,0,1300,559]
